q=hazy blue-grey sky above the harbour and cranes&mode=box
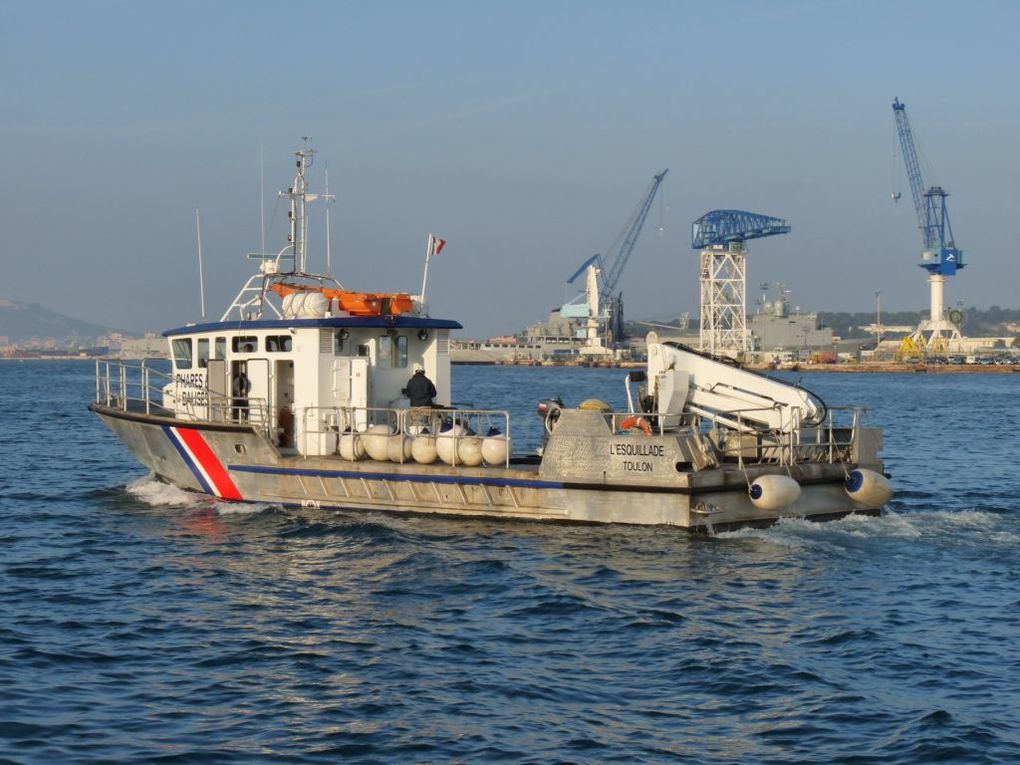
[0,0,1020,337]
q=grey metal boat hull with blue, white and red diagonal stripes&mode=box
[91,405,880,530]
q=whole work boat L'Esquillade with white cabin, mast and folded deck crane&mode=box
[90,146,893,532]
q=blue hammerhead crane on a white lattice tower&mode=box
[691,210,791,357]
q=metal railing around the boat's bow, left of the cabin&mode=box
[96,359,272,434]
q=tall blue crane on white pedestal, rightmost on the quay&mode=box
[893,98,966,356]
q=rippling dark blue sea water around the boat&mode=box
[0,361,1020,765]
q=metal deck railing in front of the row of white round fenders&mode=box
[298,406,511,467]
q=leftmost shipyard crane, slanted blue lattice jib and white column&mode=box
[561,167,669,355]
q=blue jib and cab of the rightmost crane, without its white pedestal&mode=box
[893,98,966,276]
